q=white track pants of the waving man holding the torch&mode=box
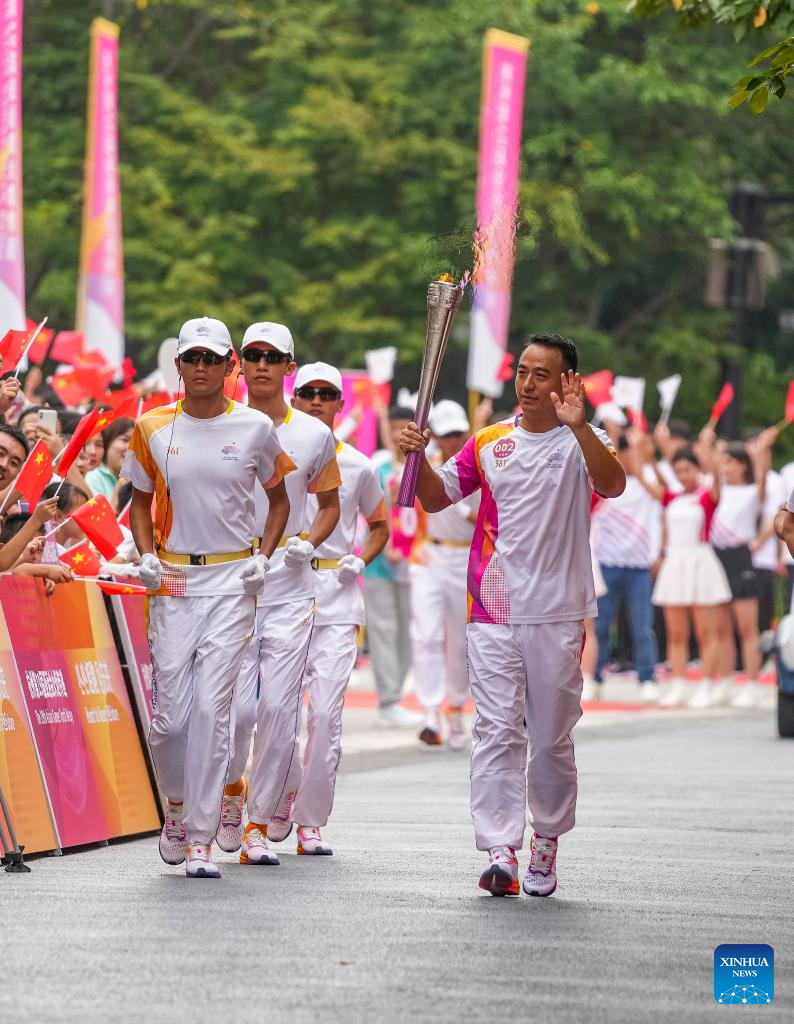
[467,622,584,850]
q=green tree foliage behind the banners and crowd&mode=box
[15,0,794,448]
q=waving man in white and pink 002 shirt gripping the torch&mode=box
[401,334,626,896]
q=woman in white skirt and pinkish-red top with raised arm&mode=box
[639,427,730,707]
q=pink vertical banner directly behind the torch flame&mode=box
[466,29,530,398]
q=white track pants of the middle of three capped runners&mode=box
[227,597,315,824]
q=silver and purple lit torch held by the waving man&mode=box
[398,273,468,508]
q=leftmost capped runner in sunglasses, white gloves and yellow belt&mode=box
[121,316,294,878]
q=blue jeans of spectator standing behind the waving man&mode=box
[595,565,657,682]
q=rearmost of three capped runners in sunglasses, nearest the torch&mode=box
[286,362,388,855]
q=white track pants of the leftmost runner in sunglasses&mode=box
[149,594,255,843]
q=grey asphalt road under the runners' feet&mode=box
[0,712,794,1024]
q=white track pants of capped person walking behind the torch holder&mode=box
[411,544,469,712]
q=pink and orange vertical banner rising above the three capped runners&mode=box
[77,17,124,367]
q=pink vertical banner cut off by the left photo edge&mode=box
[0,0,26,336]
